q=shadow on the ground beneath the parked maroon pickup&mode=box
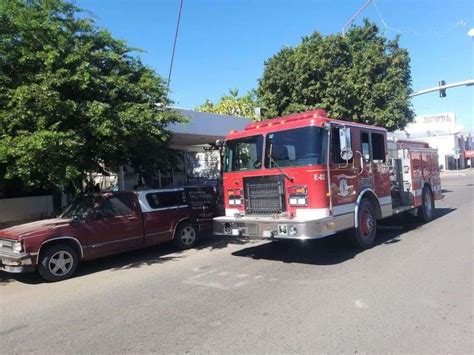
[0,235,250,286]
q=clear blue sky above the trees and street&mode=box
[76,0,474,131]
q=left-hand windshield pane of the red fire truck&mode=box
[224,135,263,172]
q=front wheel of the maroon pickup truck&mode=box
[38,244,79,282]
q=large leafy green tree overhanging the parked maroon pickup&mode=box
[0,0,182,210]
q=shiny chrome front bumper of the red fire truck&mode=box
[214,216,336,240]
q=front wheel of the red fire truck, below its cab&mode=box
[352,198,377,249]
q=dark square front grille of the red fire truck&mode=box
[244,175,286,215]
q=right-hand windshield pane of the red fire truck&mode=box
[265,126,327,168]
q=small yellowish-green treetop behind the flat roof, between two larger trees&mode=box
[195,89,259,120]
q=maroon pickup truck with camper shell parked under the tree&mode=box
[0,187,217,281]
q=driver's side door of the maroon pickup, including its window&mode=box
[85,194,144,257]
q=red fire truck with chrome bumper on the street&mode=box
[214,110,442,248]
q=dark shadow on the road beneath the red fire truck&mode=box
[232,208,456,265]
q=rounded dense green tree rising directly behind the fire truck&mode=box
[257,20,414,130]
